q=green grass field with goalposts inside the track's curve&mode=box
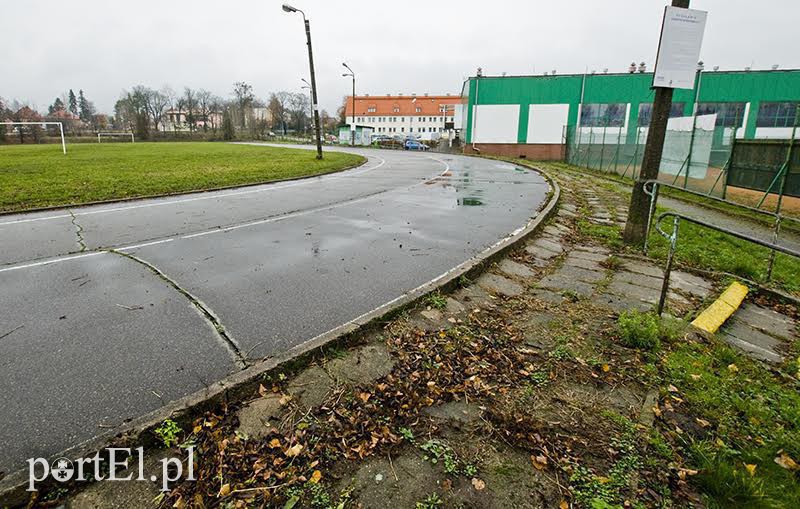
[0,142,364,211]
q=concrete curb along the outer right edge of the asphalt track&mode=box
[0,163,561,507]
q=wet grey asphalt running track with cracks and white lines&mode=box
[0,145,548,471]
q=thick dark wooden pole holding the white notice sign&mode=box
[623,0,689,244]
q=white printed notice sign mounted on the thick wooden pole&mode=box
[653,6,708,89]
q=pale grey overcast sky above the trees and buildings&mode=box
[0,0,800,113]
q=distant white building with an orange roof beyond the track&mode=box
[345,94,461,140]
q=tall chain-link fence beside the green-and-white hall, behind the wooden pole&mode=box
[566,108,800,216]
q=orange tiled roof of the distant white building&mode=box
[345,95,461,116]
